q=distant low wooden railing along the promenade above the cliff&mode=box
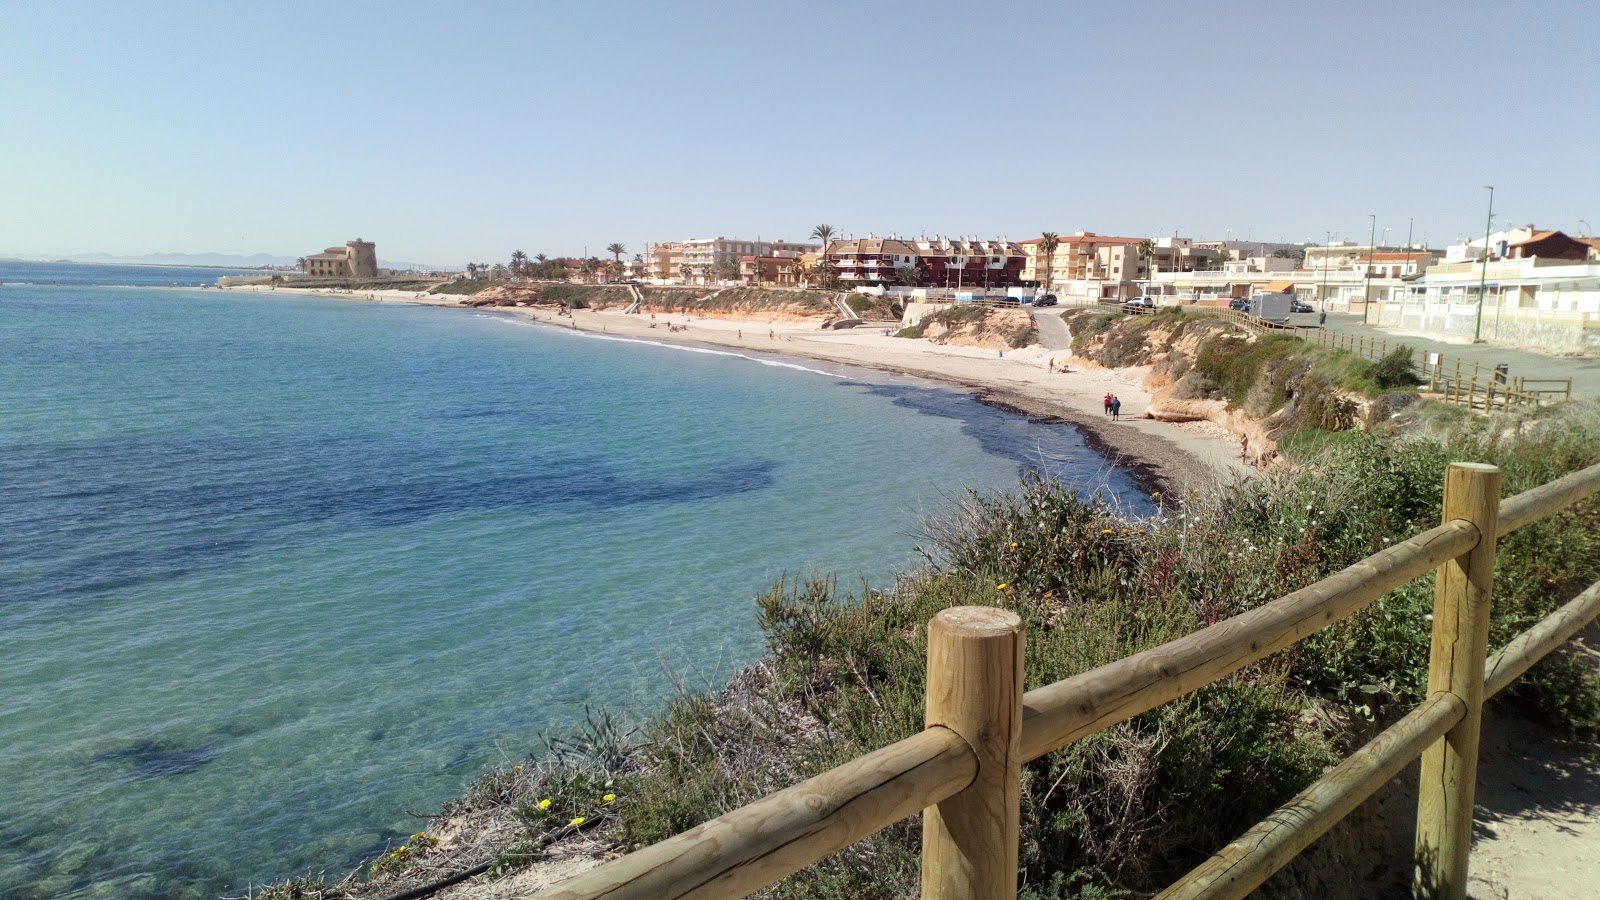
[1184,306,1573,410]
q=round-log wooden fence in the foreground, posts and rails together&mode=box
[536,463,1600,900]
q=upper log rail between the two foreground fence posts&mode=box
[1022,520,1478,759]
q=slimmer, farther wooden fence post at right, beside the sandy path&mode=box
[1413,463,1501,900]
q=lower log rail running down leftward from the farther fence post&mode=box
[1155,693,1467,900]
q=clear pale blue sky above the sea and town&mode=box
[0,0,1600,264]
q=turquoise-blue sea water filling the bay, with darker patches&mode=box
[0,267,1141,897]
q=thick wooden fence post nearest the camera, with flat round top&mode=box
[922,607,1022,900]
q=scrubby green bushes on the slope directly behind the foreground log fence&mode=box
[268,393,1600,900]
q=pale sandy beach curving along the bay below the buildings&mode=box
[222,287,1248,492]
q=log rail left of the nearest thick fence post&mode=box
[536,727,978,900]
